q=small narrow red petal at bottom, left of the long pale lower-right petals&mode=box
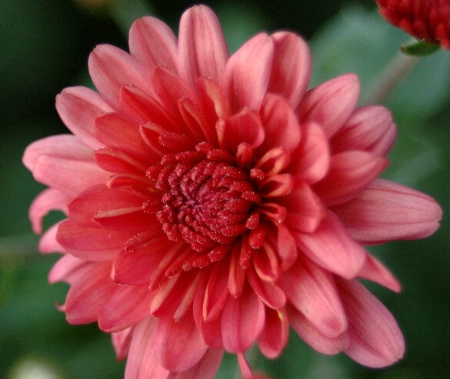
[258,308,289,359]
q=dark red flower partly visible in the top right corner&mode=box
[376,0,450,49]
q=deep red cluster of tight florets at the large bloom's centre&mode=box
[148,144,261,252]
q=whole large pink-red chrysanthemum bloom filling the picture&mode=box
[24,6,441,379]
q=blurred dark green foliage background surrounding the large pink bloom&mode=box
[0,0,450,379]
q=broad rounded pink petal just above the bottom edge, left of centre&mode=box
[155,314,208,371]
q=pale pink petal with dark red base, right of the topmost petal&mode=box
[223,33,274,111]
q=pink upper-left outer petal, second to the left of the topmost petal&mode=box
[88,45,153,109]
